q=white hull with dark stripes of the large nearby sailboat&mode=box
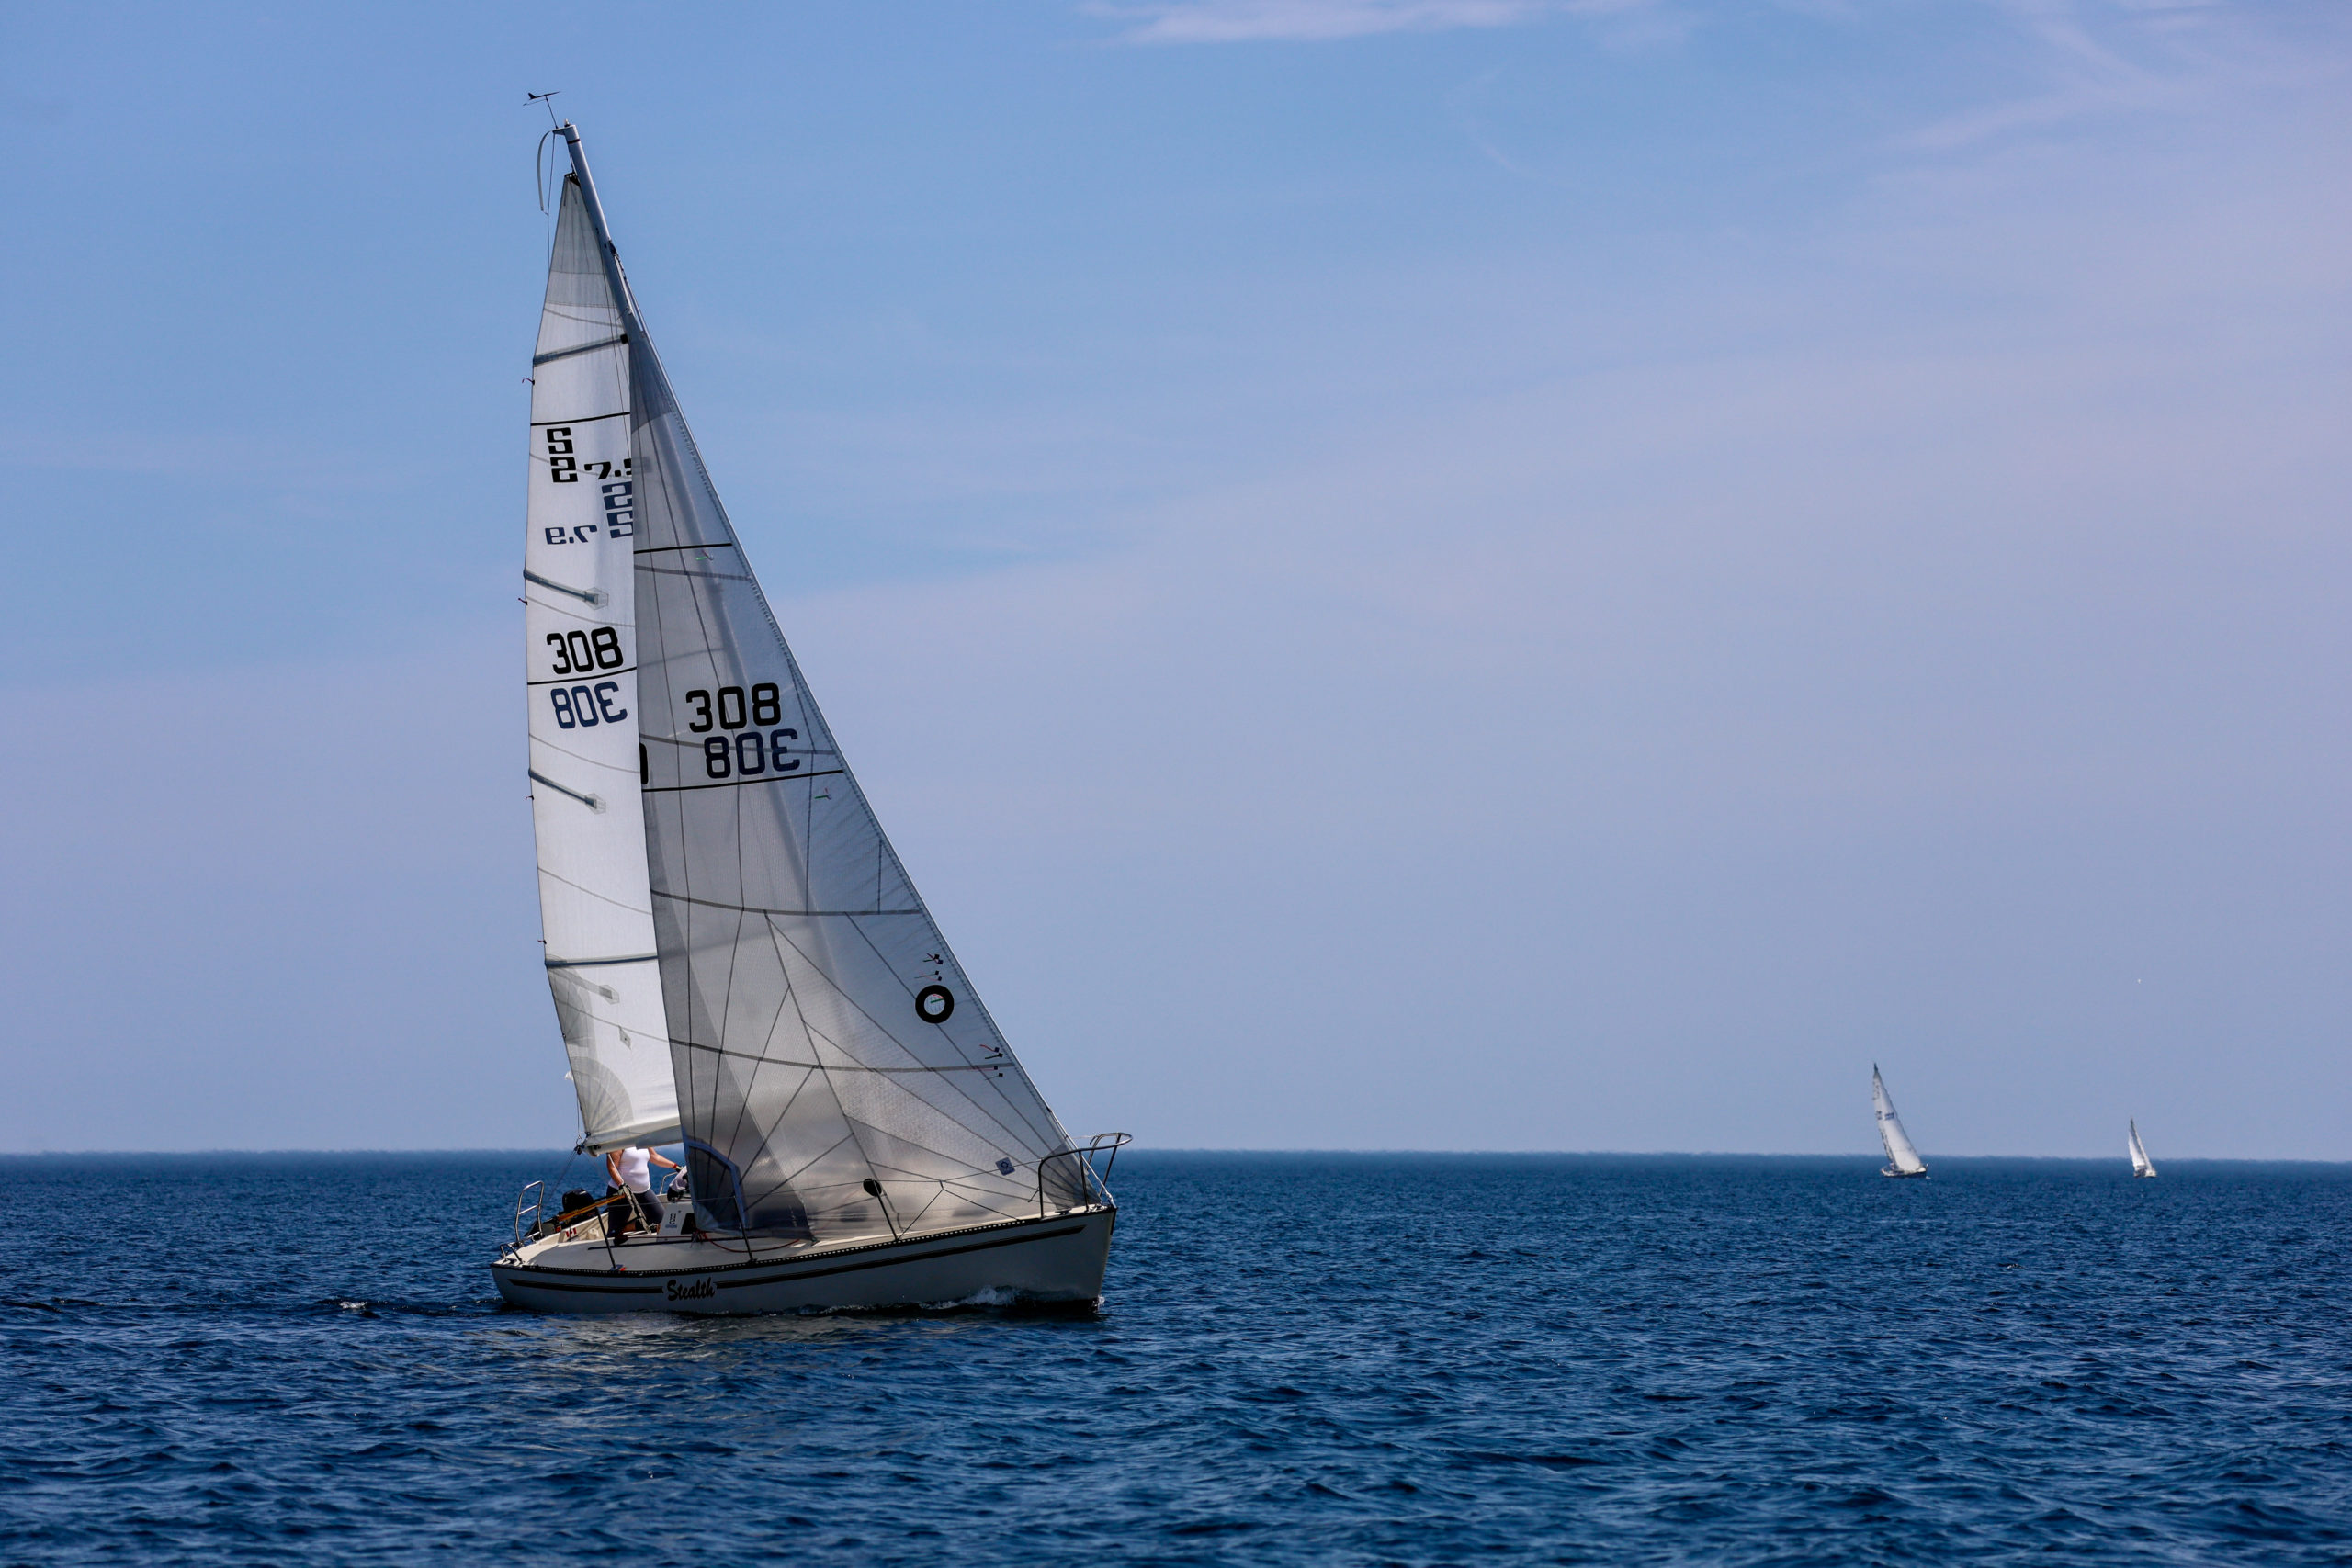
[489,1206,1117,1316]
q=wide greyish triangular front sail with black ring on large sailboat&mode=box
[550,127,1087,1239]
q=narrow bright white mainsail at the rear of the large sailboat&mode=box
[522,184,677,1149]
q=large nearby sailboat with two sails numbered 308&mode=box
[492,122,1129,1314]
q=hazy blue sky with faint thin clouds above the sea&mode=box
[0,0,2352,1159]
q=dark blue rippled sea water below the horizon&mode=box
[0,1155,2352,1568]
